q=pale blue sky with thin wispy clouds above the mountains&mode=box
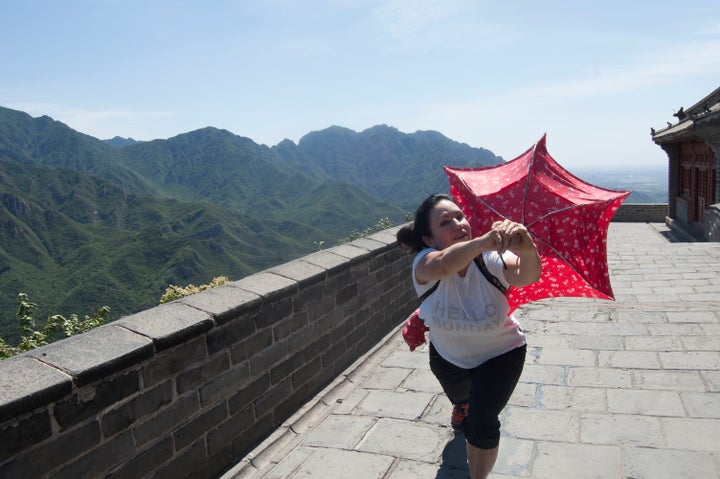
[0,0,720,171]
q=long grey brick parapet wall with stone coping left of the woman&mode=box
[0,229,416,479]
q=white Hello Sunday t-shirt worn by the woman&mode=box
[413,248,525,369]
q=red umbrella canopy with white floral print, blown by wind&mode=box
[445,136,630,312]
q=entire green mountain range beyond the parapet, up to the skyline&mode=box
[0,107,502,340]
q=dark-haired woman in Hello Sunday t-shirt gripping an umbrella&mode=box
[397,194,541,479]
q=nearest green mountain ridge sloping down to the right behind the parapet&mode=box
[0,160,334,338]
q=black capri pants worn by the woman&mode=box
[430,343,527,449]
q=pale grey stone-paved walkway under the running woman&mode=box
[222,223,720,479]
